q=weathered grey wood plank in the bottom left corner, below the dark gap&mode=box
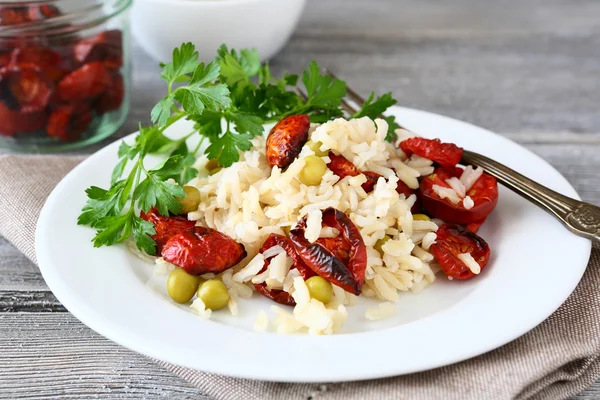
[0,313,206,400]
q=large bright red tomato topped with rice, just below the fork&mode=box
[419,167,498,225]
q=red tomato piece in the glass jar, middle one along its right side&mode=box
[57,61,112,102]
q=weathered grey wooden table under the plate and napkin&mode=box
[0,0,600,399]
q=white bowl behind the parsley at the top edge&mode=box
[132,0,306,61]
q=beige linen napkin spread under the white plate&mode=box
[0,155,600,400]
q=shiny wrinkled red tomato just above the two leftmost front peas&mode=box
[161,226,246,275]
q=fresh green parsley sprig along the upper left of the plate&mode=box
[77,43,398,254]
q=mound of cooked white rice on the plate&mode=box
[157,118,448,334]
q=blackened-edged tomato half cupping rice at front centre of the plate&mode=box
[290,207,367,295]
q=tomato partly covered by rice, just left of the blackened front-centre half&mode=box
[254,233,315,306]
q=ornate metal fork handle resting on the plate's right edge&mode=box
[462,150,600,241]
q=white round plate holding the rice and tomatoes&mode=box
[36,108,591,382]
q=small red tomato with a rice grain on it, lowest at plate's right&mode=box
[431,224,490,280]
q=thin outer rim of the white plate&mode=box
[35,107,592,382]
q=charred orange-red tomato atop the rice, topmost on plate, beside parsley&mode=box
[266,114,310,168]
